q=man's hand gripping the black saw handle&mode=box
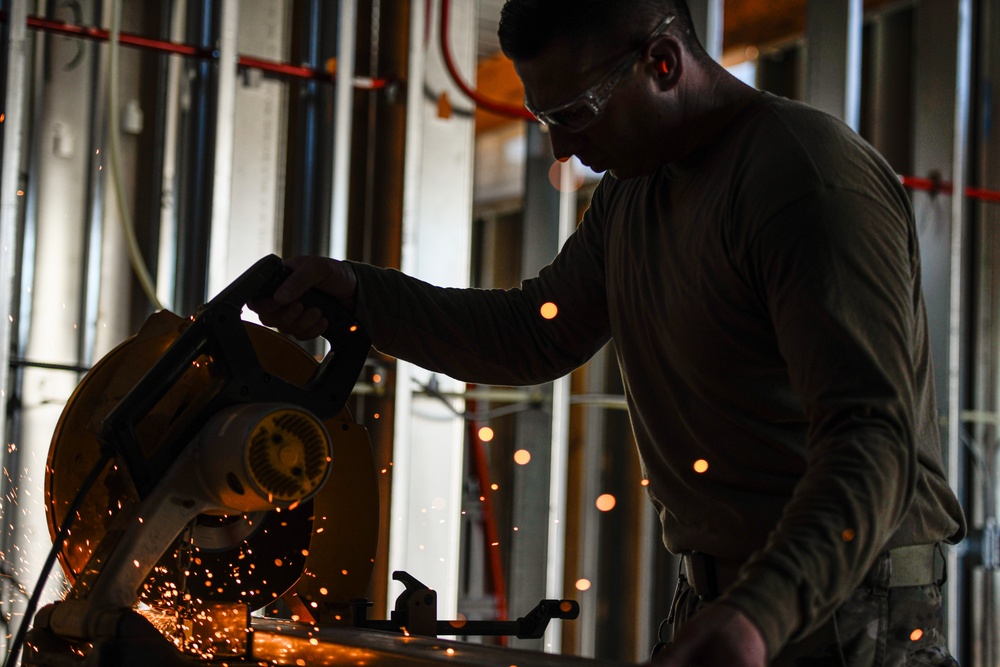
[248,257,358,340]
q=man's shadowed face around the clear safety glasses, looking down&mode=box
[514,33,665,178]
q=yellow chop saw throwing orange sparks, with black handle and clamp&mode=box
[23,255,598,667]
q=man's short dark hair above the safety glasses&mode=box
[497,0,705,60]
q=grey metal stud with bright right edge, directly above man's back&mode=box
[806,0,864,131]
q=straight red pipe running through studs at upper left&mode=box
[22,16,388,90]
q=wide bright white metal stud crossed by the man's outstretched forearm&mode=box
[389,0,476,618]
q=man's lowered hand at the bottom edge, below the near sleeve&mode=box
[652,603,767,667]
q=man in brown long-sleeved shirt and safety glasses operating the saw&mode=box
[256,0,965,667]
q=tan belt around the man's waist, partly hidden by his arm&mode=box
[681,544,941,600]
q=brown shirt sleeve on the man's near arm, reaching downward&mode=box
[726,188,922,657]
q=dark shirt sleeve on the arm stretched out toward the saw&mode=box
[352,183,610,385]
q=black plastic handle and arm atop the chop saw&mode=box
[98,255,371,498]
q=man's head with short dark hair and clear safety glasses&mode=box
[499,0,713,177]
